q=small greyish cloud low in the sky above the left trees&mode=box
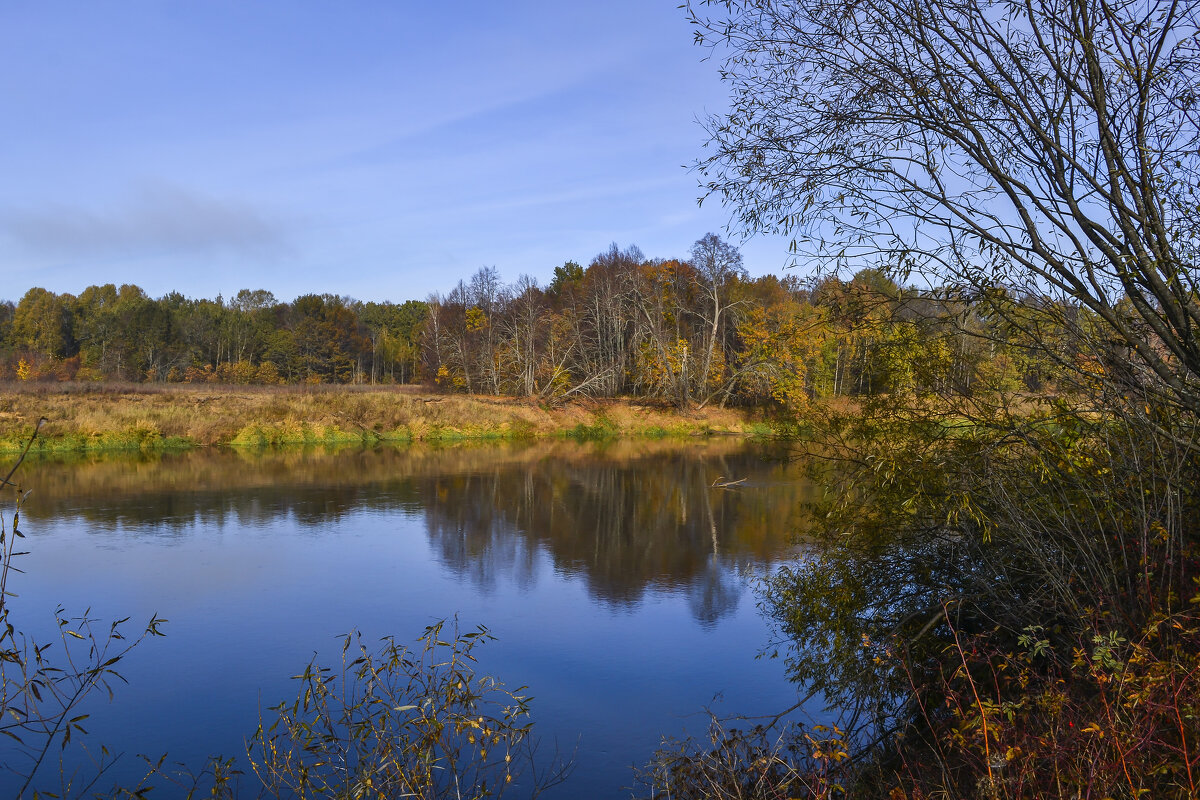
[0,184,289,257]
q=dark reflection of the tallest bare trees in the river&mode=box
[414,451,797,624]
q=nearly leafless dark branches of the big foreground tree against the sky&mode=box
[690,0,1200,414]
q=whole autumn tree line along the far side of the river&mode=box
[0,234,1070,411]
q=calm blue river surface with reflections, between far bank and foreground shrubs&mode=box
[0,440,808,796]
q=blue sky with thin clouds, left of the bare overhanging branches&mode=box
[0,0,788,302]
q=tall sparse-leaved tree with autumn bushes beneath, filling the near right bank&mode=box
[689,0,1200,798]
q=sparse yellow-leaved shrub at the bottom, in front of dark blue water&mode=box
[248,621,569,798]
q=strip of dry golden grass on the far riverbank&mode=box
[0,384,772,451]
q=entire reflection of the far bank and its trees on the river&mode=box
[18,439,808,626]
